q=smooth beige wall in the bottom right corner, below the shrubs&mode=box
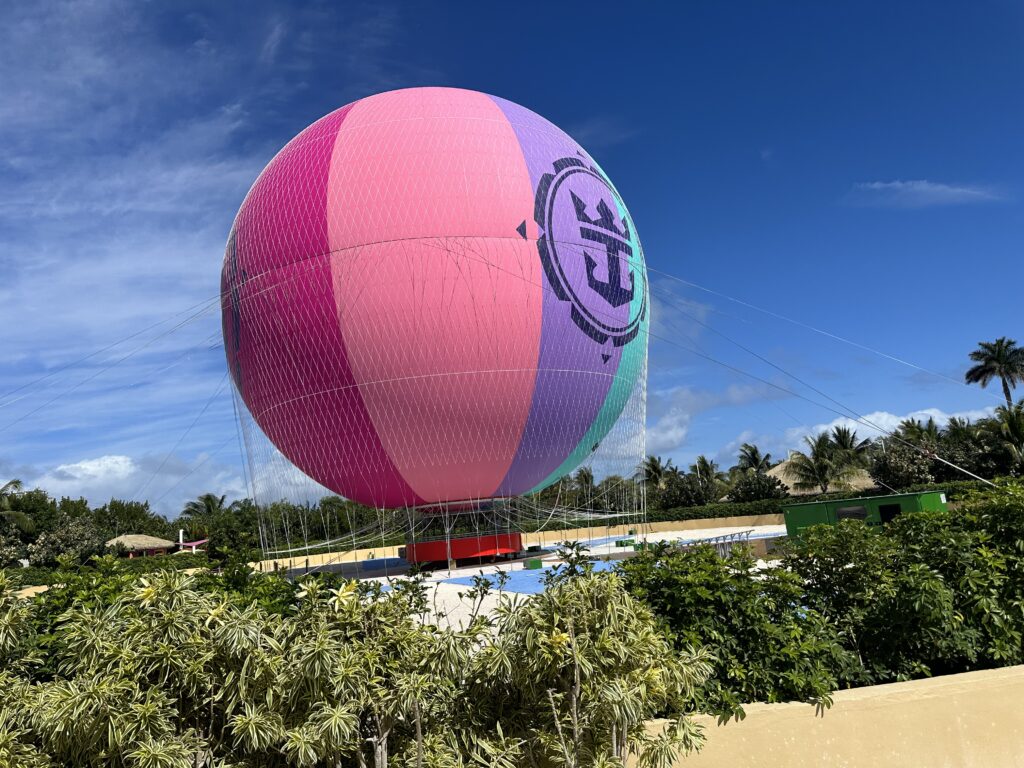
[647,667,1024,768]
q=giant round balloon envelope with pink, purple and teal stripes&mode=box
[221,88,649,507]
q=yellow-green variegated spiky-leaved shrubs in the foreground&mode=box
[0,571,711,768]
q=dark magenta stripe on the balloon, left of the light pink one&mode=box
[224,105,421,506]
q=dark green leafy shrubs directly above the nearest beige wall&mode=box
[622,482,1024,717]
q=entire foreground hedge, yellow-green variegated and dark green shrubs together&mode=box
[0,482,1024,768]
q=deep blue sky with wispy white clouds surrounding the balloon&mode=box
[0,0,1024,513]
